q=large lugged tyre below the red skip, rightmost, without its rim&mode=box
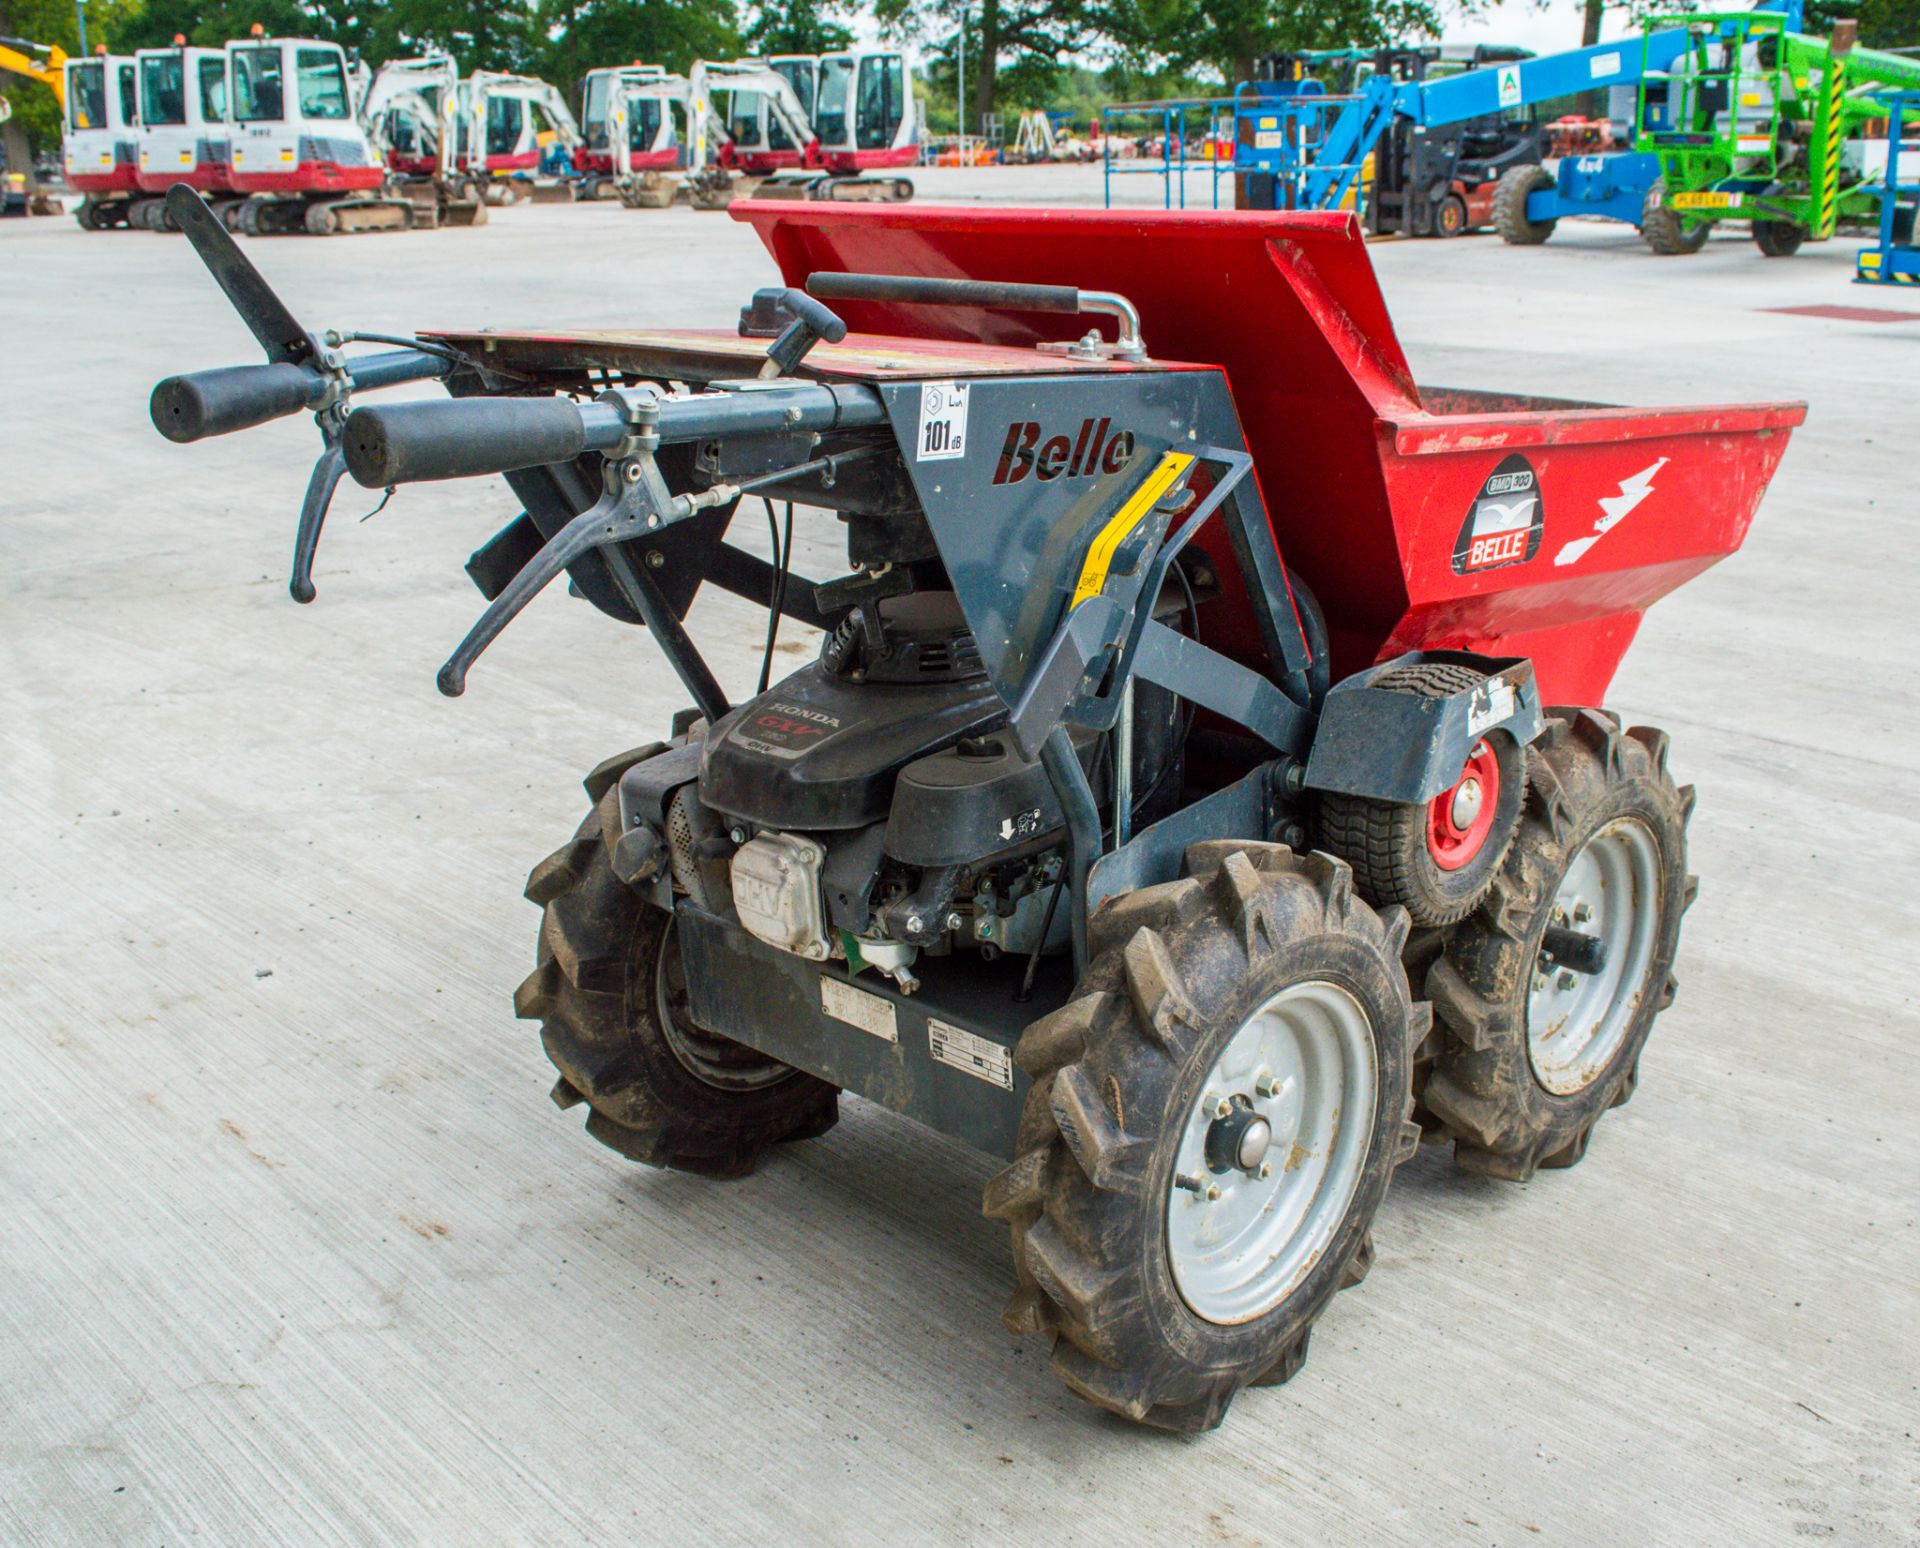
[1421,709,1695,1181]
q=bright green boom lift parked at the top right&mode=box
[1634,12,1920,257]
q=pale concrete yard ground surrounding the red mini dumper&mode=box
[0,169,1920,1548]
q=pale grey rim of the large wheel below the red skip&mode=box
[1526,816,1661,1097]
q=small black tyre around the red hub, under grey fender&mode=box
[1313,661,1526,926]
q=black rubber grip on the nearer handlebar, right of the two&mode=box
[340,398,588,490]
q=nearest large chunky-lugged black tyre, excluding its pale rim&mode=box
[983,841,1430,1431]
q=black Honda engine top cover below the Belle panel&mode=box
[701,663,1006,832]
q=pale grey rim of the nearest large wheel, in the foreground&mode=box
[1167,980,1379,1325]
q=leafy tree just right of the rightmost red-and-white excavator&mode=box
[874,0,1098,131]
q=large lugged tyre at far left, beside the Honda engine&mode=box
[513,749,839,1177]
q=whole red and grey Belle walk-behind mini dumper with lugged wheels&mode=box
[152,190,1803,1431]
